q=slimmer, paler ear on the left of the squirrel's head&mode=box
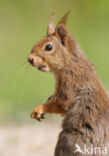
[47,11,55,35]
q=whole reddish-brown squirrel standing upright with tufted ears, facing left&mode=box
[28,12,109,156]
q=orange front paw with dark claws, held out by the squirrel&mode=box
[31,106,45,121]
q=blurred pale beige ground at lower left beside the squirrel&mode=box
[0,122,61,156]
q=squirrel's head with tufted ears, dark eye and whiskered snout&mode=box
[28,12,74,72]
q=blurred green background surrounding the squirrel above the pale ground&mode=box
[0,0,109,123]
